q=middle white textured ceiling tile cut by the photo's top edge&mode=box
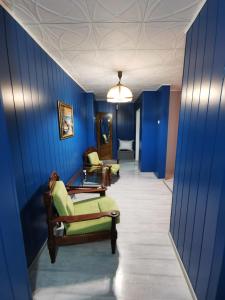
[87,0,148,22]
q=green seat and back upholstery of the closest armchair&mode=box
[52,181,119,235]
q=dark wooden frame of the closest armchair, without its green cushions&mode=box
[44,172,120,263]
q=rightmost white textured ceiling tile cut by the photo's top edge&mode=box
[145,0,202,21]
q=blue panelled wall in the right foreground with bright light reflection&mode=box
[170,0,225,300]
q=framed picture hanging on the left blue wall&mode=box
[58,101,74,140]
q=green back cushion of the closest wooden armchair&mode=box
[52,181,72,216]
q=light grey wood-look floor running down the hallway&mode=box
[30,162,192,300]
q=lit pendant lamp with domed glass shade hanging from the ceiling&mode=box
[107,71,133,103]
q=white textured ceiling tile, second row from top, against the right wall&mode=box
[138,22,186,49]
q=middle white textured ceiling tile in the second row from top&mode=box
[93,23,141,49]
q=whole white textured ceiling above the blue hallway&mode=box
[1,0,205,99]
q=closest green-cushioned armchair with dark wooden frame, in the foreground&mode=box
[44,172,120,263]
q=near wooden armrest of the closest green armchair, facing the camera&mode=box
[51,210,120,224]
